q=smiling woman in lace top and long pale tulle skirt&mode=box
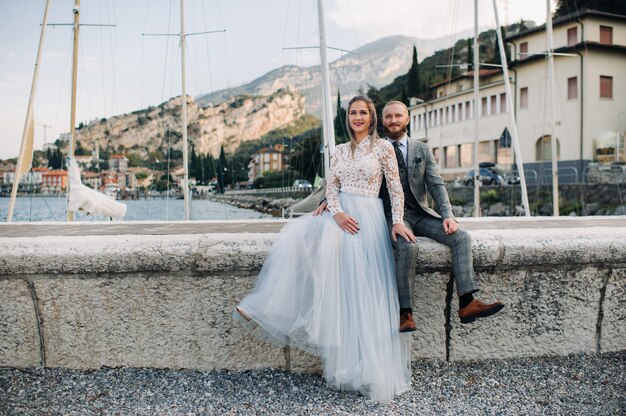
[234,96,414,400]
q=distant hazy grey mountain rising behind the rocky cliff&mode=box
[196,31,472,115]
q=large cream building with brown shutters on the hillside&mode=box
[410,9,626,183]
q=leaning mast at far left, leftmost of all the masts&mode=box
[7,0,50,222]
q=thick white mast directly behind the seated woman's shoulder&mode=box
[317,0,335,177]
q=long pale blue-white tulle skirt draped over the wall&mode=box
[234,193,411,400]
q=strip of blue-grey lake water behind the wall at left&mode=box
[0,195,272,222]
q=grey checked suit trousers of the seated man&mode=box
[388,208,478,308]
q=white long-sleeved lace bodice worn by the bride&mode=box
[326,137,404,224]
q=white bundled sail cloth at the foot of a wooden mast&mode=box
[67,158,126,218]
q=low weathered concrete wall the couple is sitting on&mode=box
[0,217,626,372]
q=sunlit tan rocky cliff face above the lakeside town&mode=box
[77,89,304,156]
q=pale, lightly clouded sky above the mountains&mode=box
[0,0,554,159]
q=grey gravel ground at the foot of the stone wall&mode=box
[0,351,626,415]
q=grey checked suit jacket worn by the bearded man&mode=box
[379,137,454,218]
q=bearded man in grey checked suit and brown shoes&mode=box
[380,101,504,332]
